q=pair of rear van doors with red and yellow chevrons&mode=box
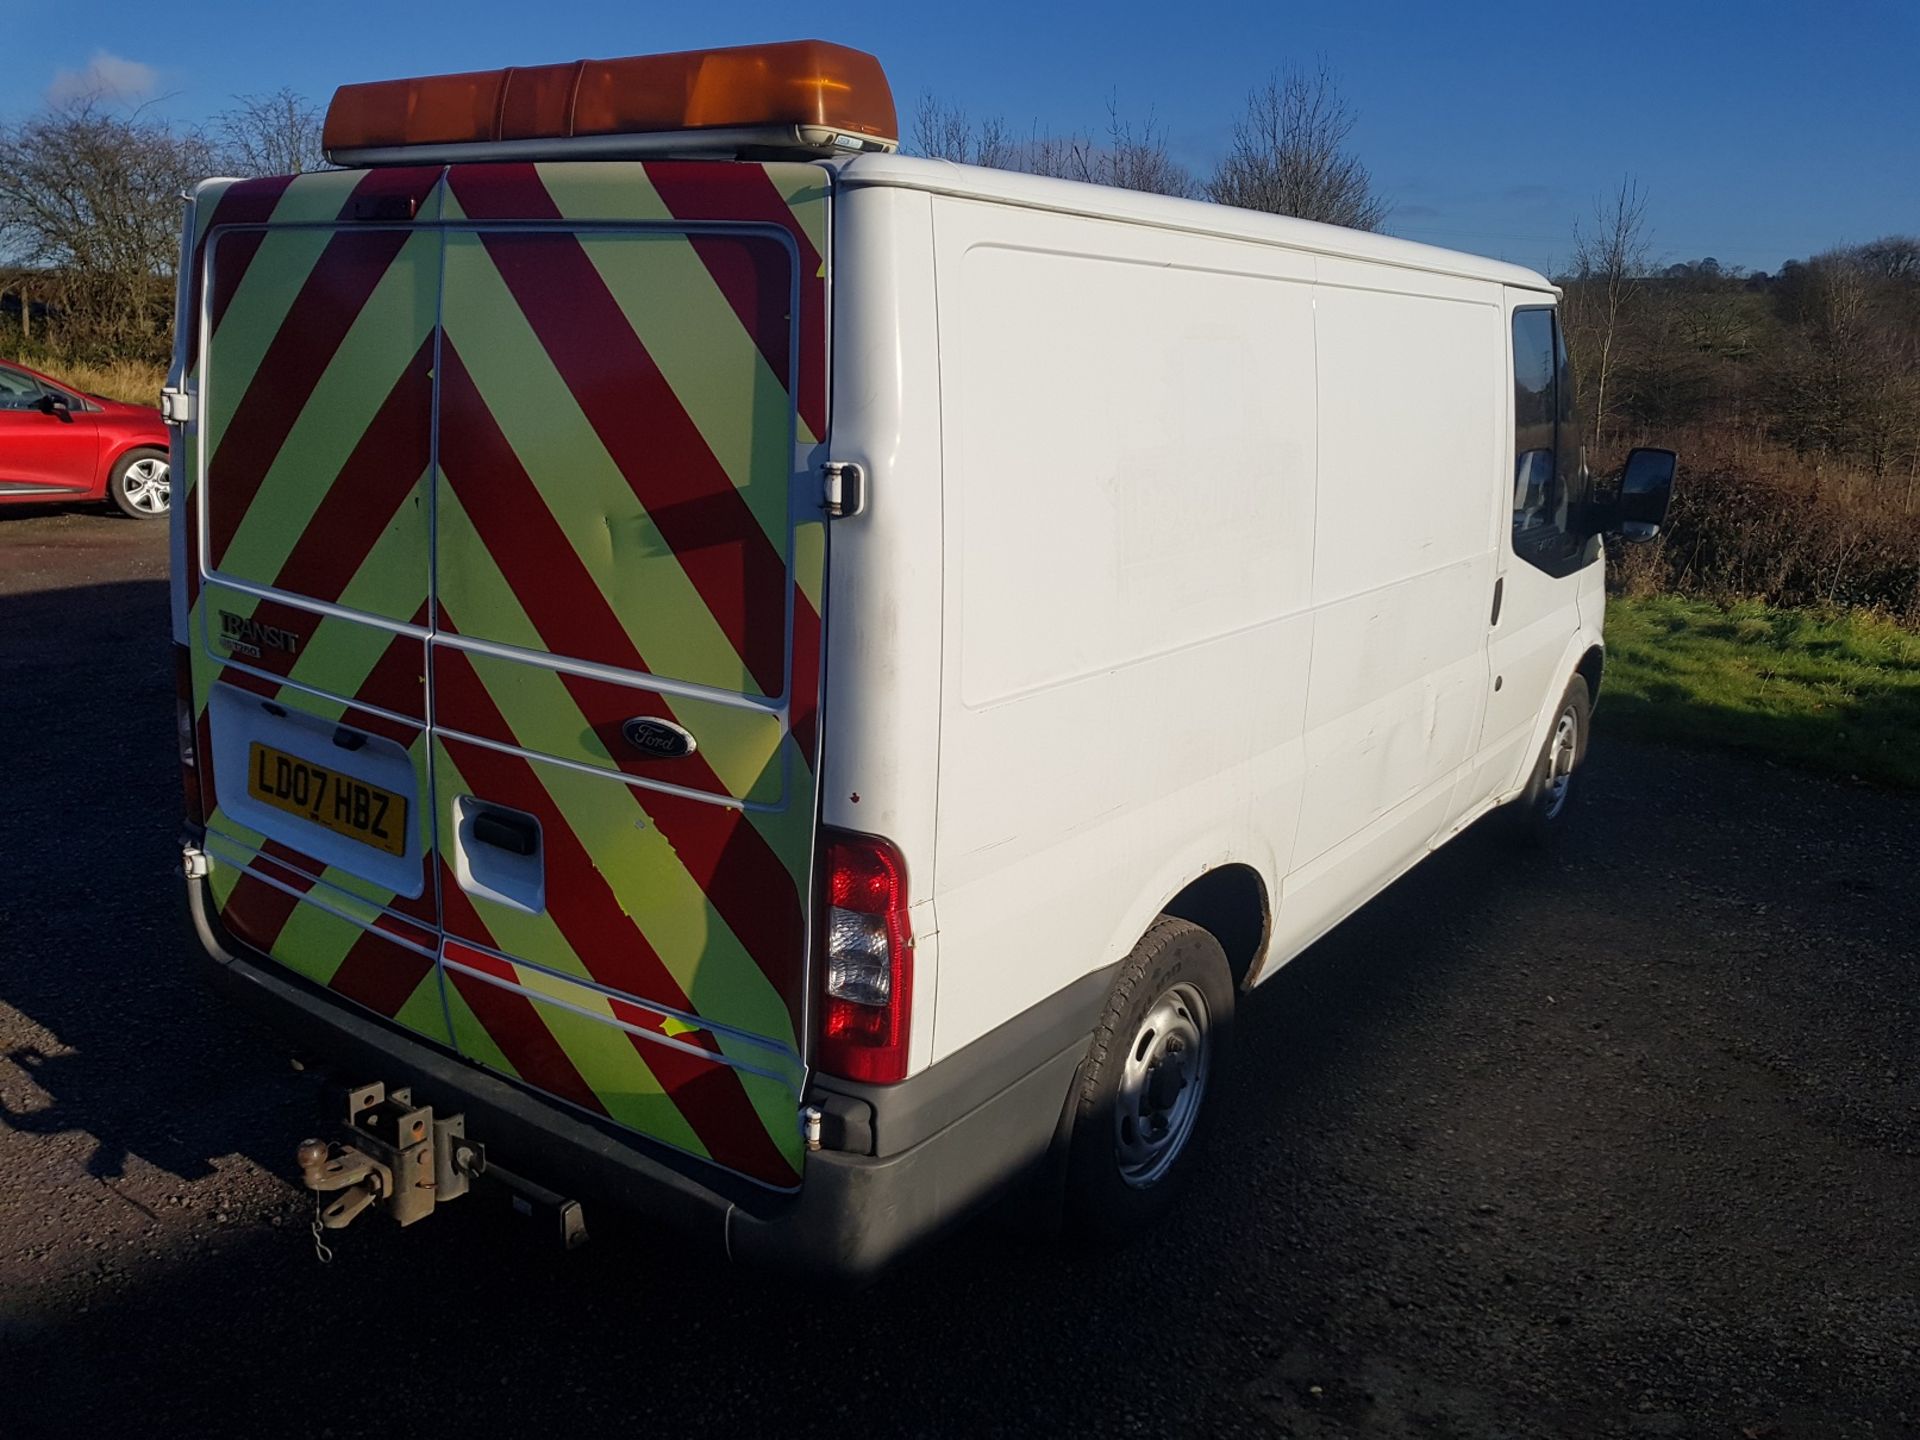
[192,161,828,1187]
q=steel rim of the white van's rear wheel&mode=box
[1114,981,1212,1190]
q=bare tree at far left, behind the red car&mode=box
[0,98,211,351]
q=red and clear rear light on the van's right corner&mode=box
[814,831,914,1085]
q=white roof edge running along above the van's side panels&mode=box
[831,154,1559,294]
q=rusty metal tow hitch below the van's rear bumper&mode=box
[298,1081,486,1231]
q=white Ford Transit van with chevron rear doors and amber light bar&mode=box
[169,42,1674,1275]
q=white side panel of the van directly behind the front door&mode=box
[1277,259,1503,958]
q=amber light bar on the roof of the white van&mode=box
[323,40,900,165]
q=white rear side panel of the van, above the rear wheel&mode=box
[933,198,1315,1054]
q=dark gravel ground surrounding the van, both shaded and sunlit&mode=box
[0,513,1920,1440]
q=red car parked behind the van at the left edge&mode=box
[0,361,173,520]
